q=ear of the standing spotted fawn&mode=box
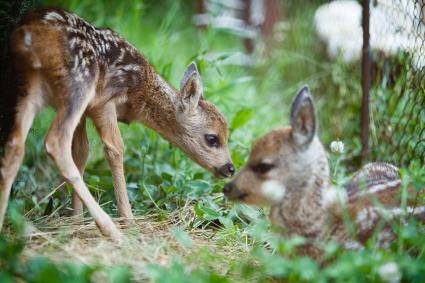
[180,62,203,112]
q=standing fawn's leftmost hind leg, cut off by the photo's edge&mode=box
[0,94,40,230]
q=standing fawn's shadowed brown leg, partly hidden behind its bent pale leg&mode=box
[72,117,89,215]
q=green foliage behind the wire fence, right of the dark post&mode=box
[370,51,425,166]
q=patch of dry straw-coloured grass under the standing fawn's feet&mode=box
[6,207,242,281]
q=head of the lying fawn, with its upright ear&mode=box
[223,86,328,205]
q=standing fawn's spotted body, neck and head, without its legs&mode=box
[11,9,234,176]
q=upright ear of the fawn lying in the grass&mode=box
[291,86,316,146]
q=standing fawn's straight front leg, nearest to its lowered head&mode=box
[91,103,134,219]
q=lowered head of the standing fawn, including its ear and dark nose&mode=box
[175,63,235,177]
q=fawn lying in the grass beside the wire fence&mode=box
[223,87,425,256]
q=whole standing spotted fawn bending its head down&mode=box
[0,9,234,239]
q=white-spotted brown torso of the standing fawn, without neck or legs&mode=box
[11,9,149,114]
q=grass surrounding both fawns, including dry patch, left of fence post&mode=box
[0,0,425,282]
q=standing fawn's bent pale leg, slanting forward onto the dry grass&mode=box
[45,86,122,240]
